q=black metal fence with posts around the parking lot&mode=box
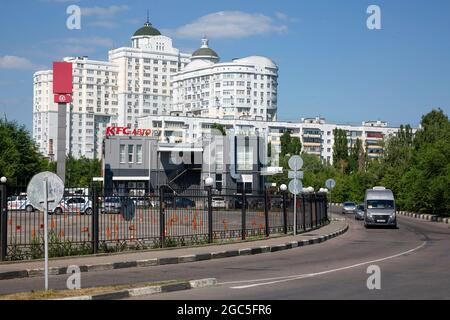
[0,185,328,260]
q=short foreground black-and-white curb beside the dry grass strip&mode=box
[53,278,217,300]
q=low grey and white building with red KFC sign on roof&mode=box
[96,129,267,194]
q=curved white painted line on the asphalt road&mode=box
[227,242,427,289]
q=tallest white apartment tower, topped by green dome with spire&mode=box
[109,21,191,127]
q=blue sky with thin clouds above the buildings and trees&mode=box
[0,0,450,129]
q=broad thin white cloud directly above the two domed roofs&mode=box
[165,11,287,38]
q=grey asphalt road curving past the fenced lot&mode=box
[0,208,450,300]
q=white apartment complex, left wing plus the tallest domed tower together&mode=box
[33,22,190,160]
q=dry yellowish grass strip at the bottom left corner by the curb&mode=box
[0,280,184,300]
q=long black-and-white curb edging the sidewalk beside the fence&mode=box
[0,219,349,280]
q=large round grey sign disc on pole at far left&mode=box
[27,172,64,211]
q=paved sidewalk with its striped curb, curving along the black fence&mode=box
[0,220,348,280]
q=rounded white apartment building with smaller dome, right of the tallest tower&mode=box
[170,38,278,121]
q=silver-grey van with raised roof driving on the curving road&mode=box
[364,187,397,228]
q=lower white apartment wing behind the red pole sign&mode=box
[33,57,118,160]
